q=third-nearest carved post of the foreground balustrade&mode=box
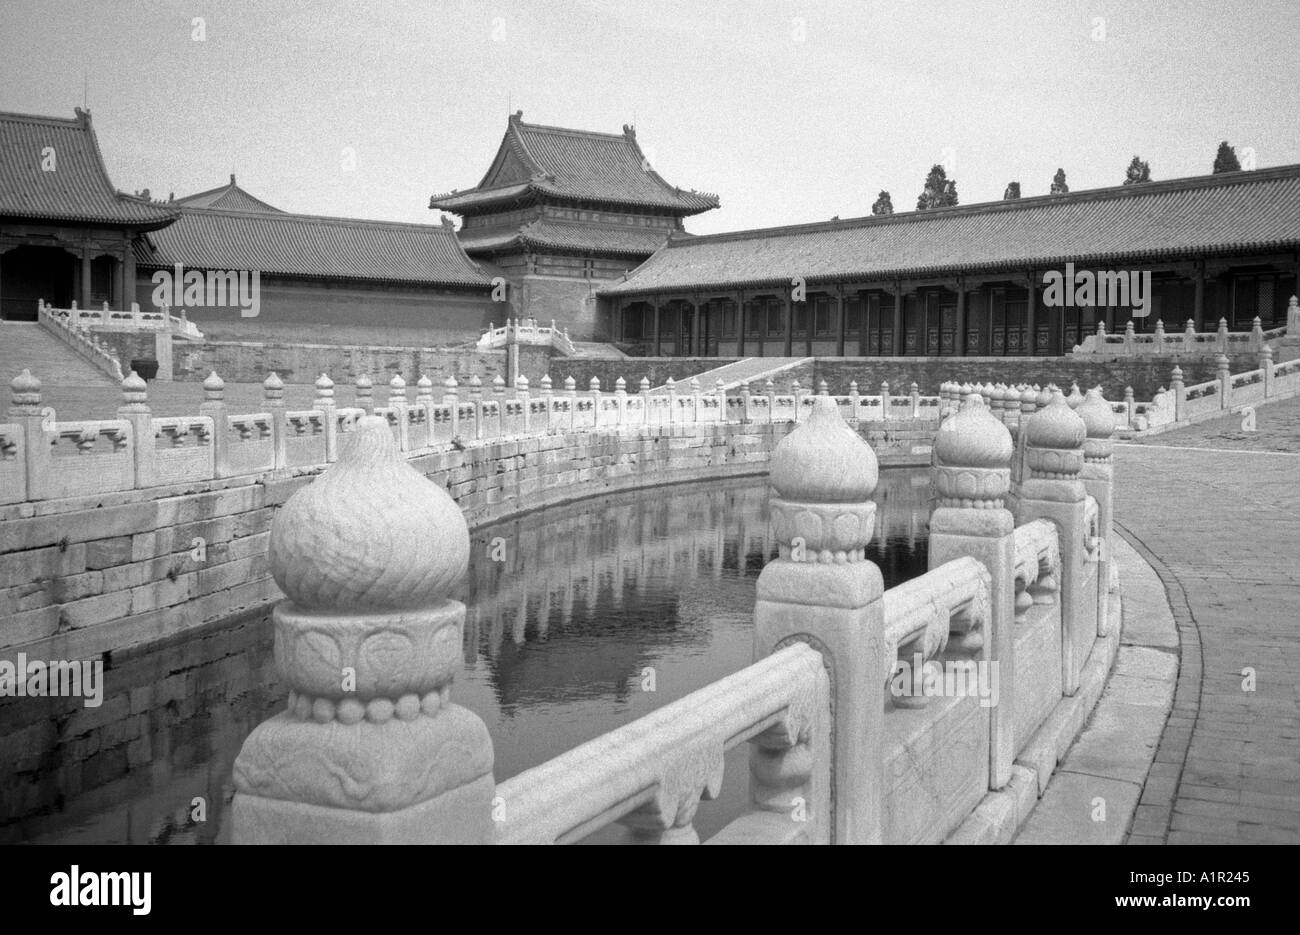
[930,393,1017,789]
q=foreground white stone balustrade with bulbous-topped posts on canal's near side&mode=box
[234,390,1119,844]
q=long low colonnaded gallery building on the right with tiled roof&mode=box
[599,165,1300,356]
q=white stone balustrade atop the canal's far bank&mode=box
[0,369,939,503]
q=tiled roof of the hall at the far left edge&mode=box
[0,108,177,230]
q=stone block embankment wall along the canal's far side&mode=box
[0,419,935,659]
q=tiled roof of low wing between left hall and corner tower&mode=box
[137,208,490,287]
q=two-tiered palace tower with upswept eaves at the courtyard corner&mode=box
[429,111,718,338]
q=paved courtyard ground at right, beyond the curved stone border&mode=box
[1115,399,1300,844]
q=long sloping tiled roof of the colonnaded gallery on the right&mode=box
[601,165,1300,295]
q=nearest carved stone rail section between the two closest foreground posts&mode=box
[495,644,829,844]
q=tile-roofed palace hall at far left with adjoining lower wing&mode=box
[0,109,506,345]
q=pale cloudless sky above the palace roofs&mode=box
[0,0,1300,233]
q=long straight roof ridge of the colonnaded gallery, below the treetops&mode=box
[666,163,1300,247]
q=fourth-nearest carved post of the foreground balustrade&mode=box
[1015,390,1097,694]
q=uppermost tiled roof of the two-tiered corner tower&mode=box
[429,112,718,216]
